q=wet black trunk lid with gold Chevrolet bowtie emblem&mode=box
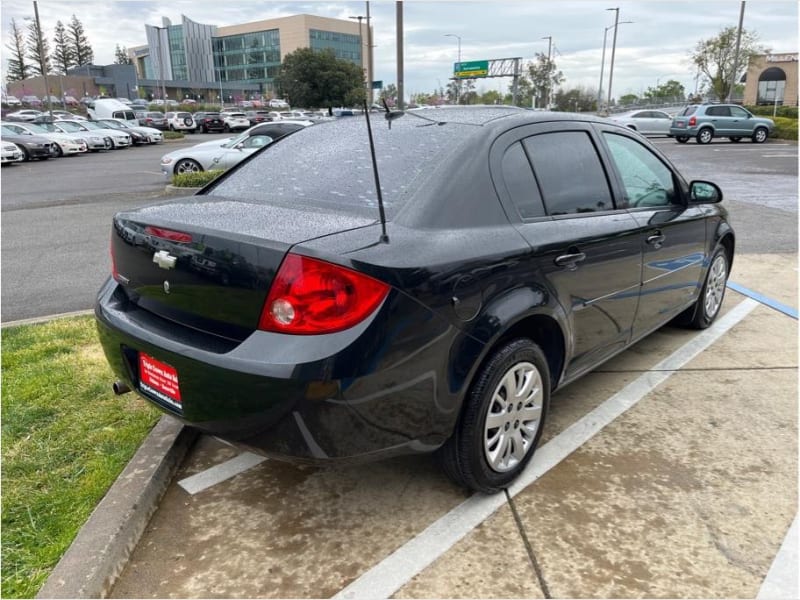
[111,196,374,340]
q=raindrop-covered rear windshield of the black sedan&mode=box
[209,114,479,217]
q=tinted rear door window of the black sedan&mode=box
[524,131,614,216]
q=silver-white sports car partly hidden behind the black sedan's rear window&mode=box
[161,121,312,177]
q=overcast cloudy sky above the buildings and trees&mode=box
[0,0,798,97]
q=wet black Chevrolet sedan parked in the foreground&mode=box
[95,107,734,492]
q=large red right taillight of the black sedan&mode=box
[258,254,389,335]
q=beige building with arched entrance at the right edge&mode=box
[744,52,798,106]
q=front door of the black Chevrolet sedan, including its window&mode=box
[598,126,706,337]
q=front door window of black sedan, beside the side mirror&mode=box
[603,133,678,208]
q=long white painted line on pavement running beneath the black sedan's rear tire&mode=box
[333,298,759,599]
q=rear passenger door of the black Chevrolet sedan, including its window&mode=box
[493,123,641,379]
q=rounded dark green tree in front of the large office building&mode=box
[275,48,366,109]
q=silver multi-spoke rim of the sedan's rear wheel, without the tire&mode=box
[483,362,544,473]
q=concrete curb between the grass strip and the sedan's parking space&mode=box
[36,416,197,598]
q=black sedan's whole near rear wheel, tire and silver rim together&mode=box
[437,338,550,494]
